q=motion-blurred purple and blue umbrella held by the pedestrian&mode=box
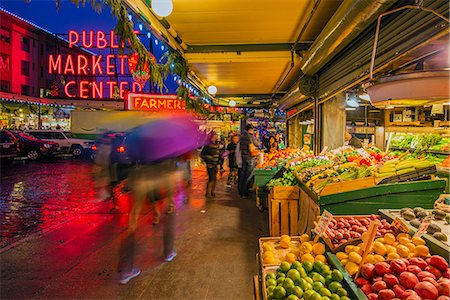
[125,115,206,163]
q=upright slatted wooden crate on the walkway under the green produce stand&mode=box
[269,194,298,236]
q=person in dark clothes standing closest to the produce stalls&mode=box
[238,124,260,198]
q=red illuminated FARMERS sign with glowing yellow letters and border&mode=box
[127,93,186,111]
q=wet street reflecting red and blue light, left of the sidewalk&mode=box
[0,160,98,248]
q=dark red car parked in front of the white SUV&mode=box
[6,130,60,160]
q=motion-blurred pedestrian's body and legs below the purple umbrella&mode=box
[118,159,182,284]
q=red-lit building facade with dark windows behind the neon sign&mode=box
[0,9,93,97]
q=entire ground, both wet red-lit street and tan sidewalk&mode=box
[0,160,267,299]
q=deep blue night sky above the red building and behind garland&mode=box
[0,0,177,93]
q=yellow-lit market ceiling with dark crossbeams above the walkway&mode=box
[125,0,343,106]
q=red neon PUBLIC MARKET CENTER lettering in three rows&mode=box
[48,30,142,99]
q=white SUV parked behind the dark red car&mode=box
[25,130,94,157]
